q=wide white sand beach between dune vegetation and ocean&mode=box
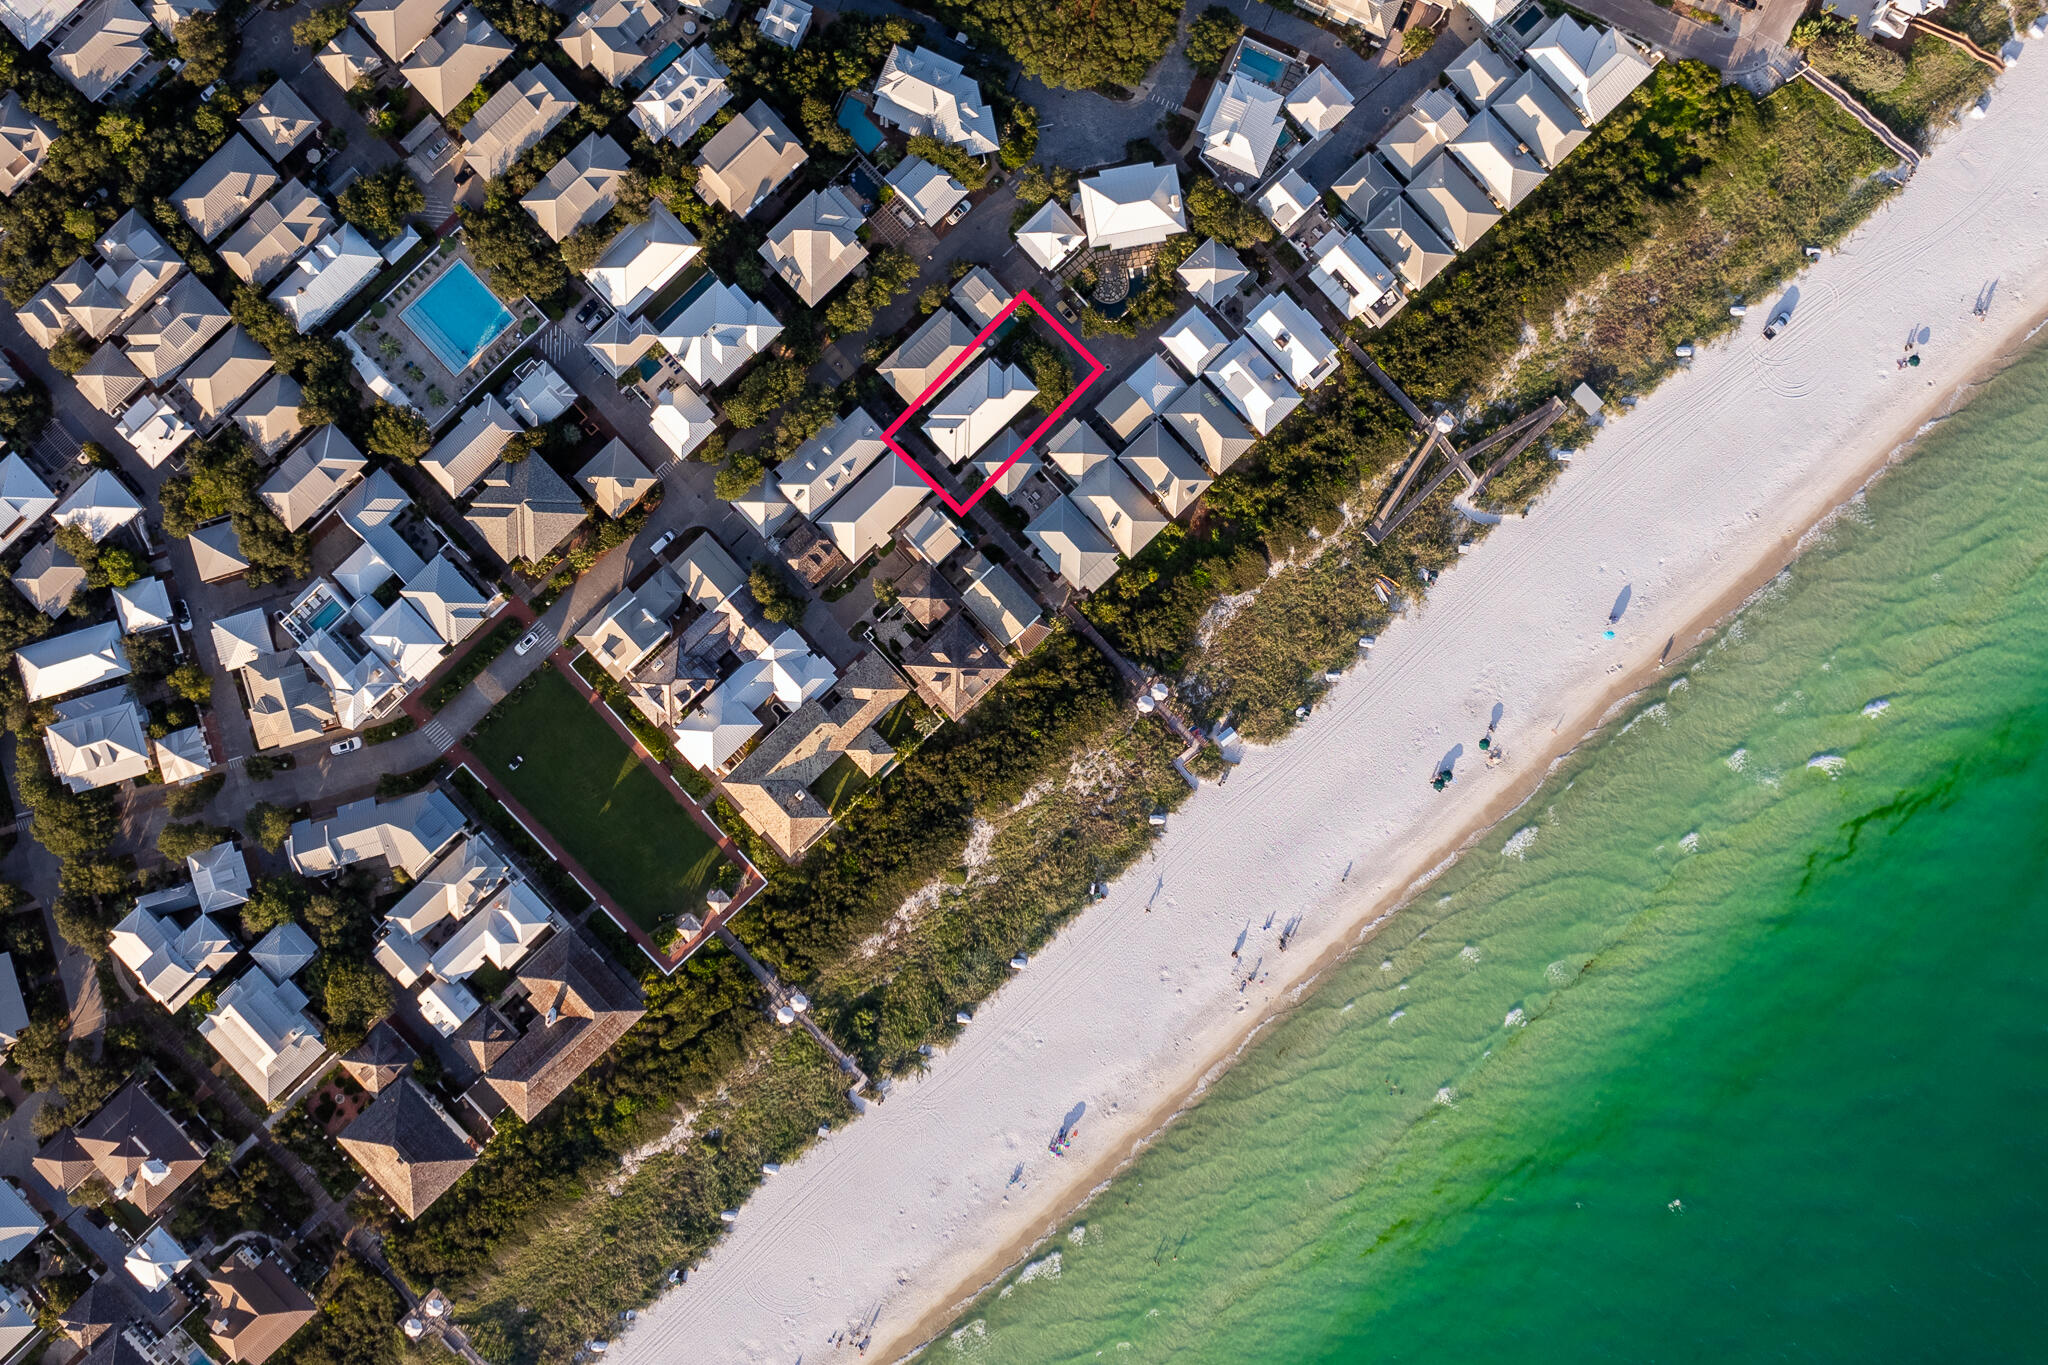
[606,53,2048,1365]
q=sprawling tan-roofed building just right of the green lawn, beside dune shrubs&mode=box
[719,650,909,857]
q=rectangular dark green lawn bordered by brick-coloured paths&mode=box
[471,667,721,933]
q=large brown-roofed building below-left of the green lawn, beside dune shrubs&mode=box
[457,931,645,1124]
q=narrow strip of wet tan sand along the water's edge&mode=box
[879,288,2048,1361]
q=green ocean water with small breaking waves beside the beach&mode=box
[928,335,2048,1365]
